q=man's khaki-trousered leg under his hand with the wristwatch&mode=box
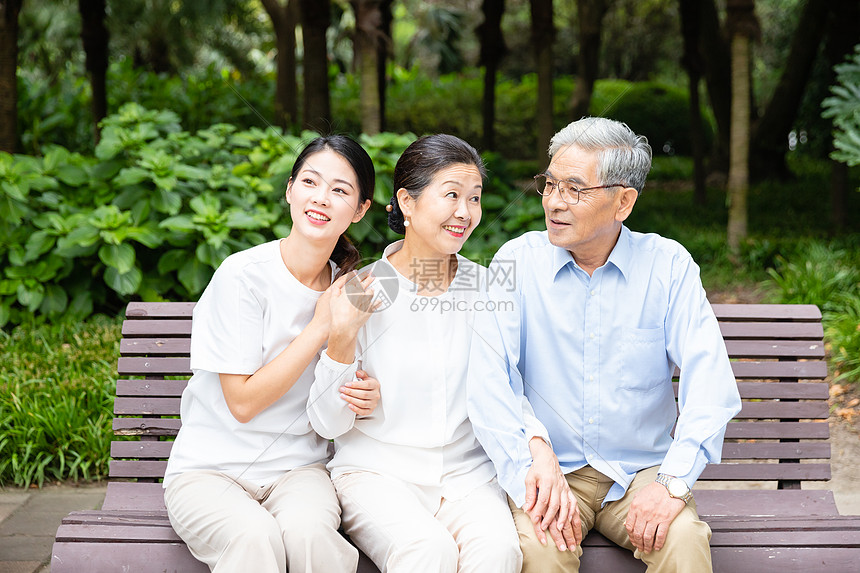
[594,467,712,573]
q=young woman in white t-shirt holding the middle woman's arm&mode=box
[164,136,379,573]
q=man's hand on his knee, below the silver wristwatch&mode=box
[624,482,686,553]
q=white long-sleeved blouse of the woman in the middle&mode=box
[308,241,549,505]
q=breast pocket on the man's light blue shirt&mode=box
[620,328,669,392]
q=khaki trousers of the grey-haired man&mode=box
[508,466,712,573]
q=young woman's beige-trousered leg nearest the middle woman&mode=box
[262,464,358,573]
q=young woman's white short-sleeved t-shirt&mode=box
[164,240,336,487]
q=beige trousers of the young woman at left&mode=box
[164,464,358,573]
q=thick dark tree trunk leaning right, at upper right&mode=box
[750,0,828,179]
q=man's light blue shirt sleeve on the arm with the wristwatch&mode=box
[660,255,741,487]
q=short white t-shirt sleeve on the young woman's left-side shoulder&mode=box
[191,259,263,374]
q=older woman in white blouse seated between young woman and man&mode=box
[308,135,522,573]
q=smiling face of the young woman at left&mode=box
[287,149,370,239]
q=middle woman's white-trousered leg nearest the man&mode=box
[436,480,523,573]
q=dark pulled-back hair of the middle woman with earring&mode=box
[388,133,487,235]
